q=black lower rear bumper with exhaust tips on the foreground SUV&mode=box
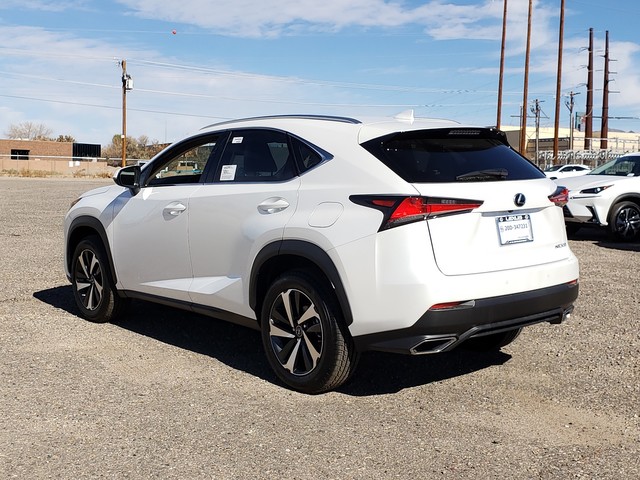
[354,283,579,355]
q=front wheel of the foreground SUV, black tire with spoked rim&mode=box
[71,235,126,323]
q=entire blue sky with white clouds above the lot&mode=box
[0,0,640,145]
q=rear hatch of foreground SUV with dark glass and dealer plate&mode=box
[363,128,571,275]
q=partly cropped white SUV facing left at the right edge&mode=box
[556,154,640,241]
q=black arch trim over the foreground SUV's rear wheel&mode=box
[249,240,353,326]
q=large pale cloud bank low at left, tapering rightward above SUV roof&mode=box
[0,27,400,144]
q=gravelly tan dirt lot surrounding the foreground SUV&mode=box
[0,178,640,479]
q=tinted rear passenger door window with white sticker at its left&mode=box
[215,129,295,182]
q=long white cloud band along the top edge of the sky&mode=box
[119,0,510,39]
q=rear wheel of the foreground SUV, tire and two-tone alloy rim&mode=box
[261,271,359,394]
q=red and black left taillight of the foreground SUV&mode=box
[350,195,482,230]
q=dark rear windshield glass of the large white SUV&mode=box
[362,129,544,183]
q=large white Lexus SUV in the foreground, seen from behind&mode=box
[65,114,578,393]
